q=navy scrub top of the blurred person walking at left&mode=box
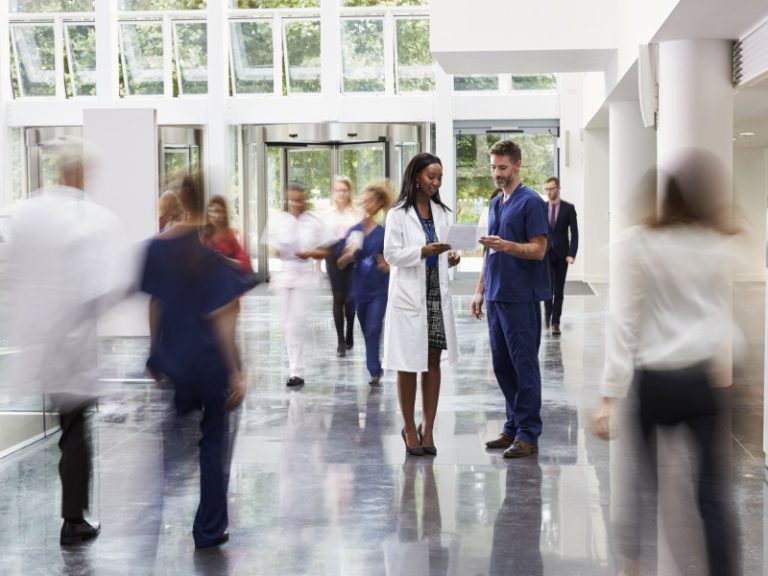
[141,229,249,384]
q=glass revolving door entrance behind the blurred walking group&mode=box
[242,123,428,280]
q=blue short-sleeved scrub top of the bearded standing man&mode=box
[484,183,552,303]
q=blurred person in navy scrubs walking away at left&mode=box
[141,176,247,548]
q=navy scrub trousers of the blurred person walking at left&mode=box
[174,382,234,547]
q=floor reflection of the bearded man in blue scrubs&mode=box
[490,462,544,576]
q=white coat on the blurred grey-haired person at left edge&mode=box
[2,186,128,396]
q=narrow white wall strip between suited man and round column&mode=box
[580,128,609,282]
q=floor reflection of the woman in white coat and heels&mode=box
[384,458,452,576]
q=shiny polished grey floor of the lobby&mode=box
[0,285,768,576]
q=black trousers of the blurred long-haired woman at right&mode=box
[624,364,739,576]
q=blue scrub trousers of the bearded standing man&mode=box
[488,302,541,444]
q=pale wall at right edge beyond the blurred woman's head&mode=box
[733,148,768,282]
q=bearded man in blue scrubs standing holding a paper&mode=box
[472,140,551,458]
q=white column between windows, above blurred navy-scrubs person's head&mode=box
[203,2,228,202]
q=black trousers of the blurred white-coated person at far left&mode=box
[53,394,92,520]
